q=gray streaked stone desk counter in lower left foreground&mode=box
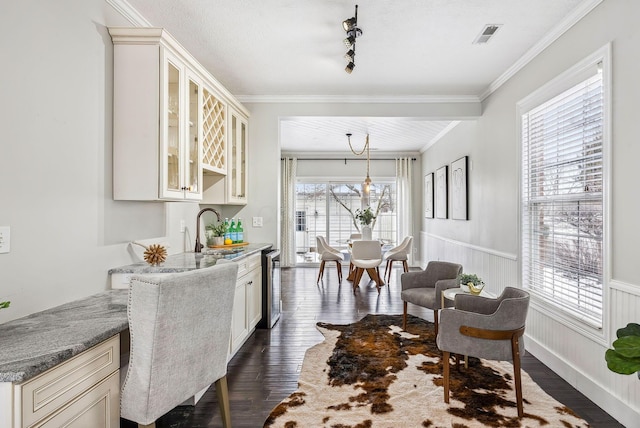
[0,290,128,382]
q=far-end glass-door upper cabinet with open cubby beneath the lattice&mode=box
[202,106,249,205]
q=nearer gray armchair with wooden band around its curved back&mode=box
[436,287,529,417]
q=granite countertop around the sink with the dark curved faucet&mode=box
[109,244,272,274]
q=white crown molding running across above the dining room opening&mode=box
[236,95,480,104]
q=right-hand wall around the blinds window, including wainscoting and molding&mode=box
[422,0,640,426]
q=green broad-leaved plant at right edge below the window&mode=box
[604,323,640,379]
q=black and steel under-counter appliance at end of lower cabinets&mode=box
[257,248,282,328]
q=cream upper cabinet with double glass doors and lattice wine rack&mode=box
[109,28,248,203]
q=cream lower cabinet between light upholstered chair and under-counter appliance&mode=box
[229,254,262,358]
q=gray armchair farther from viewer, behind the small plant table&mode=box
[400,261,462,334]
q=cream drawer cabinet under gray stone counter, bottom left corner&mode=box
[0,335,120,428]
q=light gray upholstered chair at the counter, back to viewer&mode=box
[120,263,238,427]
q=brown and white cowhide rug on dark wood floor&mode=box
[264,315,588,428]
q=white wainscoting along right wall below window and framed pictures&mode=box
[420,232,640,426]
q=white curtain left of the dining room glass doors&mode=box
[280,158,298,267]
